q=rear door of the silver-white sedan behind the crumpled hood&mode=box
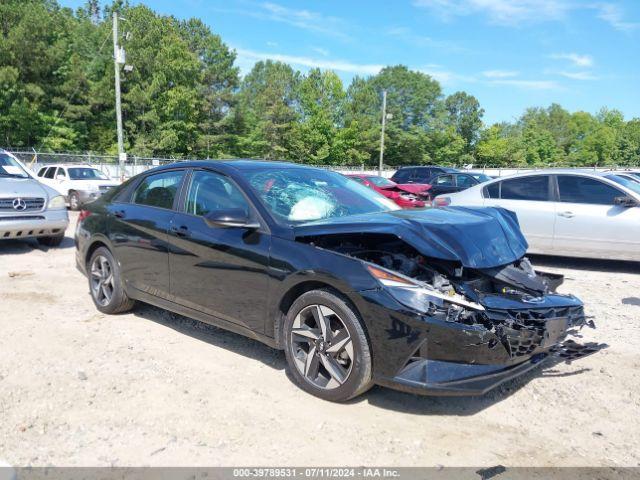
[484,175,556,254]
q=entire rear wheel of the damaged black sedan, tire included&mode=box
[88,247,135,314]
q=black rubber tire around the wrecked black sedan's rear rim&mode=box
[87,247,135,314]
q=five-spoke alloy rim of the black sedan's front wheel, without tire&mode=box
[291,305,355,390]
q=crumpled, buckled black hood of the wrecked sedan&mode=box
[294,207,528,269]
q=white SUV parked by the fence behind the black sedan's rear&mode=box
[38,164,119,210]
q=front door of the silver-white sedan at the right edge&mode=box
[553,175,640,260]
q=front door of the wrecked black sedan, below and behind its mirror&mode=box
[169,170,271,332]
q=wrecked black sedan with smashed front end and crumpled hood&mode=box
[75,160,596,401]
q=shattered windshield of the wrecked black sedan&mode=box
[242,167,400,225]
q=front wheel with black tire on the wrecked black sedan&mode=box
[283,290,372,402]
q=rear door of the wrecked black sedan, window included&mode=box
[108,169,185,298]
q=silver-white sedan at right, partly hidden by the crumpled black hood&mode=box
[433,170,640,261]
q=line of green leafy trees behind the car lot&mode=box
[0,0,640,166]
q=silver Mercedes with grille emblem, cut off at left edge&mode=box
[0,150,69,247]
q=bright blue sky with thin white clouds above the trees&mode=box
[60,0,640,123]
